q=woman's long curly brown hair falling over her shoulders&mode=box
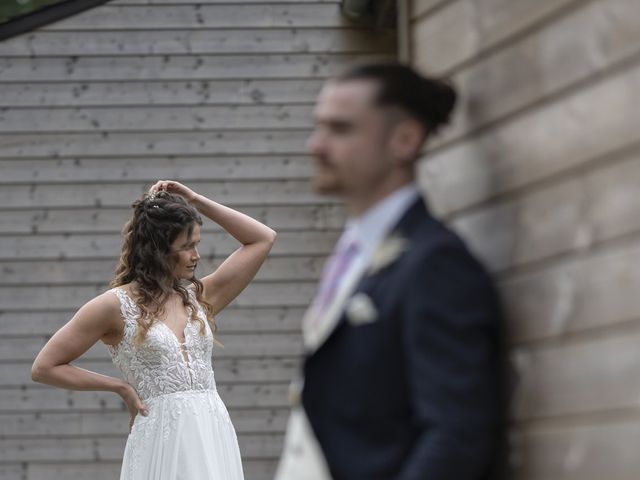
[111,191,217,345]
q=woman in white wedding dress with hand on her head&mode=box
[32,180,276,480]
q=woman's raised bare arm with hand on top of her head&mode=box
[150,180,276,315]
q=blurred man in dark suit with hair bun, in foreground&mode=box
[276,64,503,480]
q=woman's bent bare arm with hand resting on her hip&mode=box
[31,292,146,426]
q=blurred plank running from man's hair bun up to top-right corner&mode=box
[431,0,640,147]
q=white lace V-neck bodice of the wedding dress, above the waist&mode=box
[107,288,216,401]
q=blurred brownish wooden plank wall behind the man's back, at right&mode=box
[408,0,640,480]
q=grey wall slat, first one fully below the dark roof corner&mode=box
[0,54,390,83]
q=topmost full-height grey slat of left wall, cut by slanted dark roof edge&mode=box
[46,3,350,31]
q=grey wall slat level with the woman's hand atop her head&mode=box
[0,179,330,208]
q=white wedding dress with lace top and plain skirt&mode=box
[108,288,244,480]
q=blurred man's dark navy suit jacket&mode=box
[302,199,504,480]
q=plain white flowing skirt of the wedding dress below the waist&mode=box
[120,390,244,480]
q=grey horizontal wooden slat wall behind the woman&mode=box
[0,0,395,480]
